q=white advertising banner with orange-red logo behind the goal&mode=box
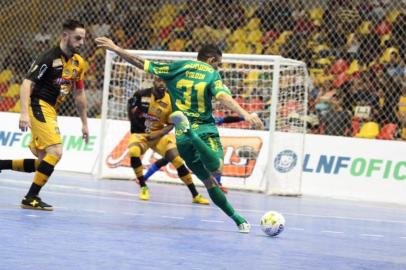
[100,120,268,190]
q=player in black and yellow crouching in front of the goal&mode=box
[128,77,209,204]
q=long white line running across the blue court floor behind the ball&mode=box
[0,179,406,225]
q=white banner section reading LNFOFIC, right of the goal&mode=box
[302,135,406,204]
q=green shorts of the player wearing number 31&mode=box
[176,123,224,180]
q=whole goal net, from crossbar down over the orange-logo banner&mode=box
[102,51,308,184]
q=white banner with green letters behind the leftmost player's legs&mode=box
[0,112,100,173]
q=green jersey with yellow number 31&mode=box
[144,60,231,125]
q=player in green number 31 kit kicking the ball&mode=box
[95,37,263,233]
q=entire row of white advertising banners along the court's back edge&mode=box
[0,110,406,204]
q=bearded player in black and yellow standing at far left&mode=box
[0,20,89,210]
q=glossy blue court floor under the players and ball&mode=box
[0,171,406,270]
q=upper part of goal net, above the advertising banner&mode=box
[106,51,308,133]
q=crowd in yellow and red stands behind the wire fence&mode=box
[0,0,406,140]
